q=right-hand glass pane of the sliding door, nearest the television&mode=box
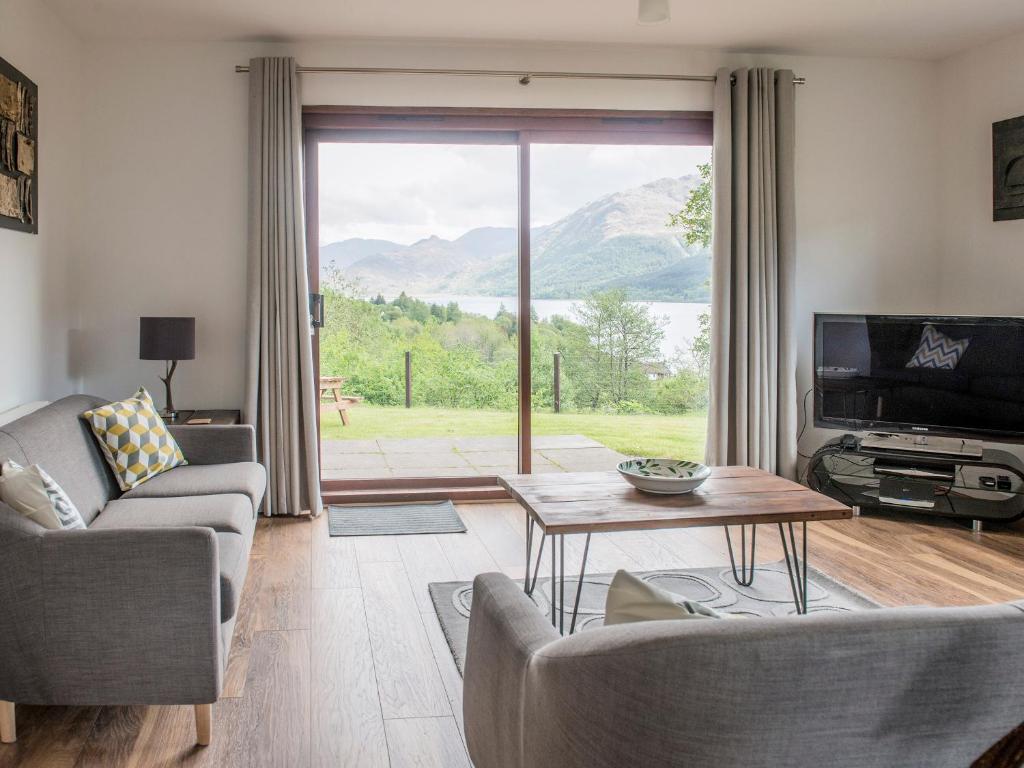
[529,143,711,472]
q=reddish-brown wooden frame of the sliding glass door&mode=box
[302,105,713,500]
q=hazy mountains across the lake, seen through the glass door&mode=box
[321,175,711,301]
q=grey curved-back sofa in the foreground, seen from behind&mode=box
[463,573,1024,768]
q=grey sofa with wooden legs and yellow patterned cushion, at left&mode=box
[0,395,266,743]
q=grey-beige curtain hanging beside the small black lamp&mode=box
[245,58,322,515]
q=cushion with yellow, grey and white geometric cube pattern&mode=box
[82,387,188,490]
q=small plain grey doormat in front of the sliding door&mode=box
[327,501,466,536]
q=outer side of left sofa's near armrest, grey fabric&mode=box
[18,527,223,705]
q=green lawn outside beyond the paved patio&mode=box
[321,404,708,461]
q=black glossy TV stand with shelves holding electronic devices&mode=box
[808,435,1024,531]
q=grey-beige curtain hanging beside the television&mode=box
[707,69,797,477]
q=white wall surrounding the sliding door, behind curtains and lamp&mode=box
[75,42,940,428]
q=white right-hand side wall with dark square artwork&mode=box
[939,29,1024,315]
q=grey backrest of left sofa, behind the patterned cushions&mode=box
[0,394,120,525]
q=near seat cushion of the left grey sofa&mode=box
[89,494,256,539]
